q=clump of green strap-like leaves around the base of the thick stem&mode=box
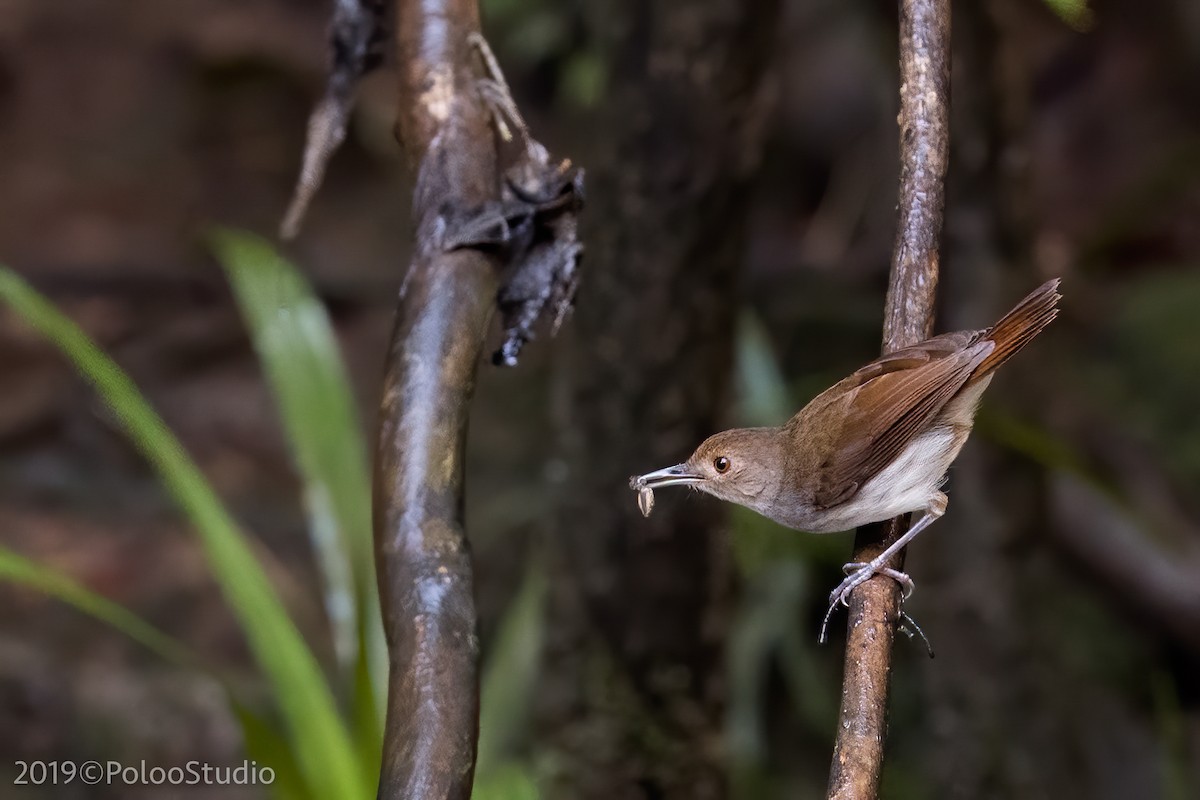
[0,237,545,800]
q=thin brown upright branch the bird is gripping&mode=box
[828,0,950,800]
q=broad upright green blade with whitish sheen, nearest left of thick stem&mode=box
[212,230,388,738]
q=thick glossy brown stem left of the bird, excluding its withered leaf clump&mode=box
[374,0,497,800]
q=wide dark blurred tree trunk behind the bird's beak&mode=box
[539,0,778,800]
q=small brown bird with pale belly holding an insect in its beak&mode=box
[630,278,1060,640]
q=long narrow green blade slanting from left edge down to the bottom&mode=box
[0,267,370,798]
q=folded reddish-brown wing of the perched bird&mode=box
[798,331,994,507]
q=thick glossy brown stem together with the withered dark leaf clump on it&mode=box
[374,0,580,800]
